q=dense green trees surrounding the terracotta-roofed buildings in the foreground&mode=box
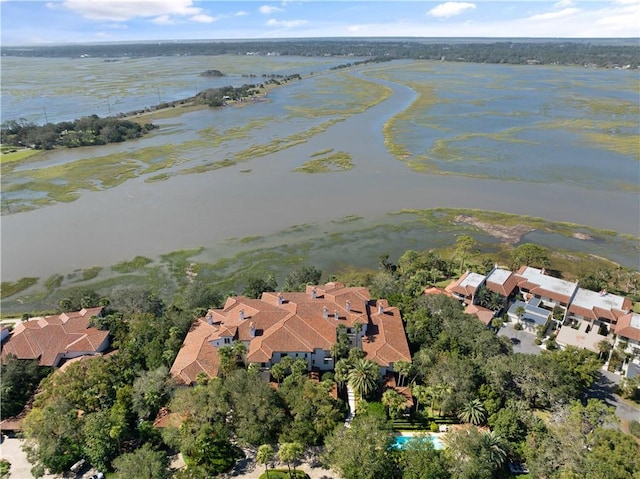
[2,255,640,479]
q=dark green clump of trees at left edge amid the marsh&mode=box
[0,115,157,150]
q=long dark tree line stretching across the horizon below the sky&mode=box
[1,39,640,68]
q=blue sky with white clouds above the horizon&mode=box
[0,0,640,45]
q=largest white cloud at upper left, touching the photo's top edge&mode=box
[63,0,202,22]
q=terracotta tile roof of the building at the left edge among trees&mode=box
[2,308,109,367]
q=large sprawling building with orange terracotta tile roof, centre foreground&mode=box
[171,283,411,384]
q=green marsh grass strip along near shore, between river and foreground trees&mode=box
[1,209,638,312]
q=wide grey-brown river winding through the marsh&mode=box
[1,55,640,281]
